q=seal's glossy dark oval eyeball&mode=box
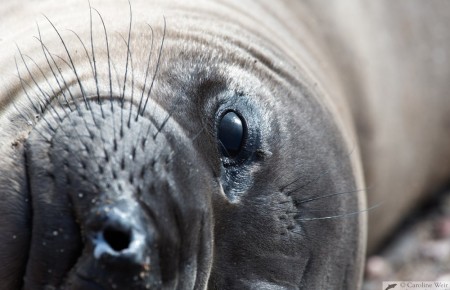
[218,111,245,158]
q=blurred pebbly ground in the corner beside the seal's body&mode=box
[363,191,450,290]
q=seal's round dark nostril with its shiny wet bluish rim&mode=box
[84,201,158,271]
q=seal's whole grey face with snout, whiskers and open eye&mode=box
[1,1,359,289]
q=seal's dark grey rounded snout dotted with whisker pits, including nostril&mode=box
[22,99,215,290]
